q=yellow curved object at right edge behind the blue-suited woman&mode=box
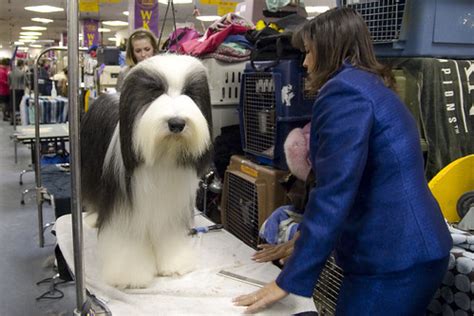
[428,155,474,223]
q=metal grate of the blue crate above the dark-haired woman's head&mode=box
[341,0,406,44]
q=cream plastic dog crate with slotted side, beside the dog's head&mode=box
[201,58,246,105]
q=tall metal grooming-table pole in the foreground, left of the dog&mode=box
[67,0,87,315]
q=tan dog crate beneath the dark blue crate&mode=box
[221,155,288,249]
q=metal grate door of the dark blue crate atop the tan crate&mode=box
[243,73,276,159]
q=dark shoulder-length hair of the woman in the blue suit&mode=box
[292,8,395,90]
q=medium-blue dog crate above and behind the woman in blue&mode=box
[339,0,474,58]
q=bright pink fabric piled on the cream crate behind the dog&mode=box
[179,24,249,56]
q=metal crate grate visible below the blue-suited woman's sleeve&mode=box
[313,256,343,316]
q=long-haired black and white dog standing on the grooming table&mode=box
[81,55,212,288]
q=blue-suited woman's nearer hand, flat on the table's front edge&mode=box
[232,281,288,313]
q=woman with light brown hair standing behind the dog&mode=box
[116,29,158,91]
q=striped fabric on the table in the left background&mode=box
[20,96,69,125]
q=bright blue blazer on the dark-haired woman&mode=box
[277,63,452,297]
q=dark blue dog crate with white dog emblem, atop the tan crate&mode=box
[239,59,315,170]
